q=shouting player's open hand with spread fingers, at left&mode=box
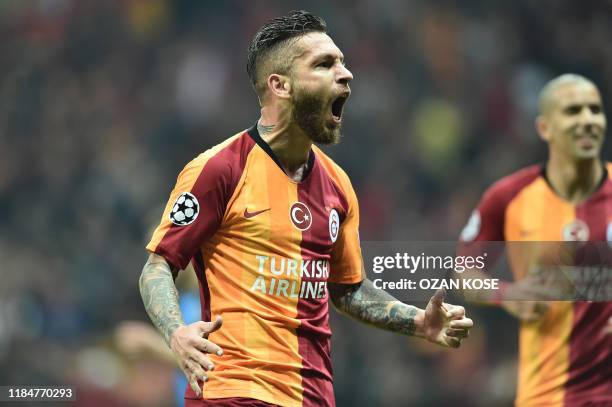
[170,316,223,396]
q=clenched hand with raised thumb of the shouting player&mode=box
[423,289,474,348]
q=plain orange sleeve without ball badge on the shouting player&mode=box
[329,180,364,284]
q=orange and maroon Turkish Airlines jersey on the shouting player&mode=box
[147,127,363,406]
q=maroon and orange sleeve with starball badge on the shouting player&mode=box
[147,153,232,269]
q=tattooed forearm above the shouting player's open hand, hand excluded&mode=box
[139,254,185,345]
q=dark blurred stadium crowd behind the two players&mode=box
[0,0,612,406]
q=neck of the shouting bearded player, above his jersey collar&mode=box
[257,107,312,181]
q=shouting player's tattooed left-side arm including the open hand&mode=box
[139,253,223,395]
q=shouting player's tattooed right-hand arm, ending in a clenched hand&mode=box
[328,279,473,348]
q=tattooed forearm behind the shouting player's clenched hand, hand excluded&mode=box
[328,279,419,335]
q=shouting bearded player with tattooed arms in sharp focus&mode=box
[140,11,473,406]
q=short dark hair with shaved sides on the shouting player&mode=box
[247,10,327,97]
